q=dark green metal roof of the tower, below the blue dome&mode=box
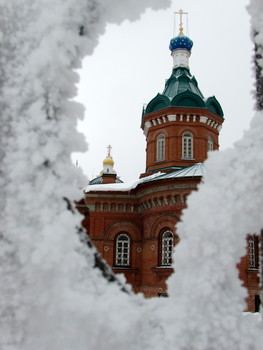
[143,67,224,118]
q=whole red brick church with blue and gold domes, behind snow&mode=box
[78,16,259,311]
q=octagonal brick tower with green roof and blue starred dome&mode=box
[141,10,224,177]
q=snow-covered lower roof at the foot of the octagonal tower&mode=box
[84,163,205,193]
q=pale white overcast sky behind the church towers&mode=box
[73,0,254,182]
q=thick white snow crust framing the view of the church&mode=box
[0,0,263,350]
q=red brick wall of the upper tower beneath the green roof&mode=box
[144,107,223,172]
